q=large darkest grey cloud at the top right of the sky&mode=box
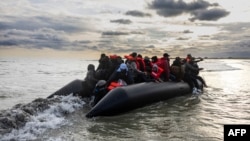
[148,0,229,21]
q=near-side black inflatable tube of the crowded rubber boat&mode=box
[86,82,202,118]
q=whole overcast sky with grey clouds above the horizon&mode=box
[0,0,250,57]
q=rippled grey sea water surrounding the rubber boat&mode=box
[0,57,250,141]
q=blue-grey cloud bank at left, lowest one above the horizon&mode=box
[0,28,95,50]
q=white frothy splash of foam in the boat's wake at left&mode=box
[0,94,85,141]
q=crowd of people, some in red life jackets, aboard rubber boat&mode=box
[82,52,207,105]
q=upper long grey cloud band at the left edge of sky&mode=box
[0,16,89,33]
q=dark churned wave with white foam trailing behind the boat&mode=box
[0,94,85,141]
